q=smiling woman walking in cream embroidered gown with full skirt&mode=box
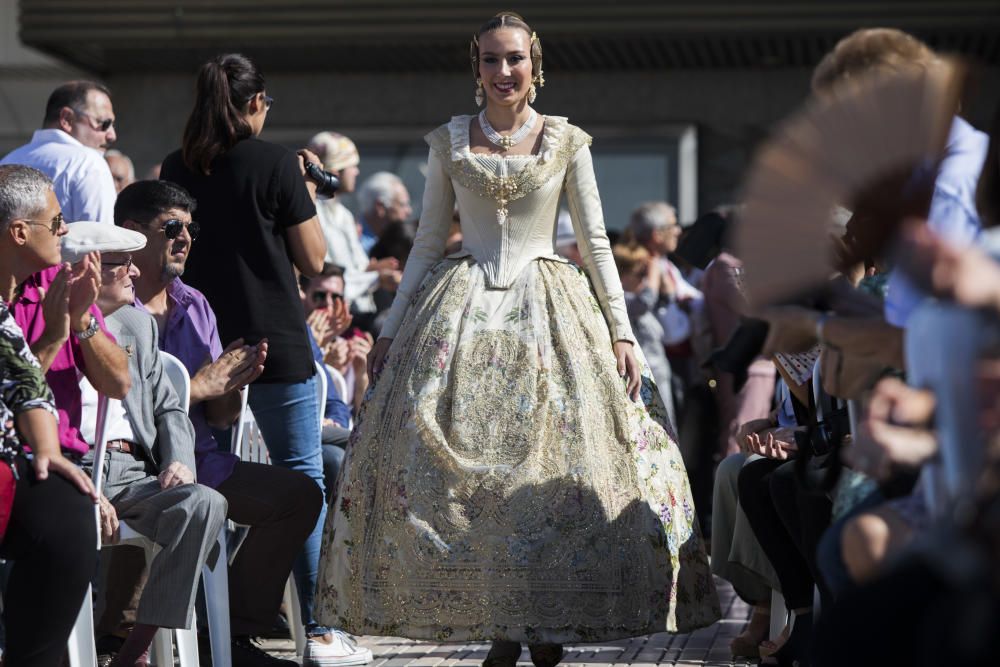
[317,14,719,665]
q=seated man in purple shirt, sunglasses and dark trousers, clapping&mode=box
[115,181,346,666]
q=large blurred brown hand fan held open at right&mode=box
[735,60,965,306]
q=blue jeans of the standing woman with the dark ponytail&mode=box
[249,375,326,628]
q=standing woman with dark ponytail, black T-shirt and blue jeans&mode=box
[160,54,371,667]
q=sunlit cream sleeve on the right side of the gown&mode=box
[566,146,636,343]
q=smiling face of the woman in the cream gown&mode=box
[479,28,532,106]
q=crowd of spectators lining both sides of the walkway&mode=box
[0,23,1000,667]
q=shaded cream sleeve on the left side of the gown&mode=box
[379,149,458,338]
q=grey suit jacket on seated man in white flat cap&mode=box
[105,306,196,472]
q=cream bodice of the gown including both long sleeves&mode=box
[381,116,635,342]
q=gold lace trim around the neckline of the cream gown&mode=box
[427,123,592,224]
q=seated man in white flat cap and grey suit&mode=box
[63,222,226,666]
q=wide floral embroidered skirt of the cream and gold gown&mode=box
[316,258,720,643]
